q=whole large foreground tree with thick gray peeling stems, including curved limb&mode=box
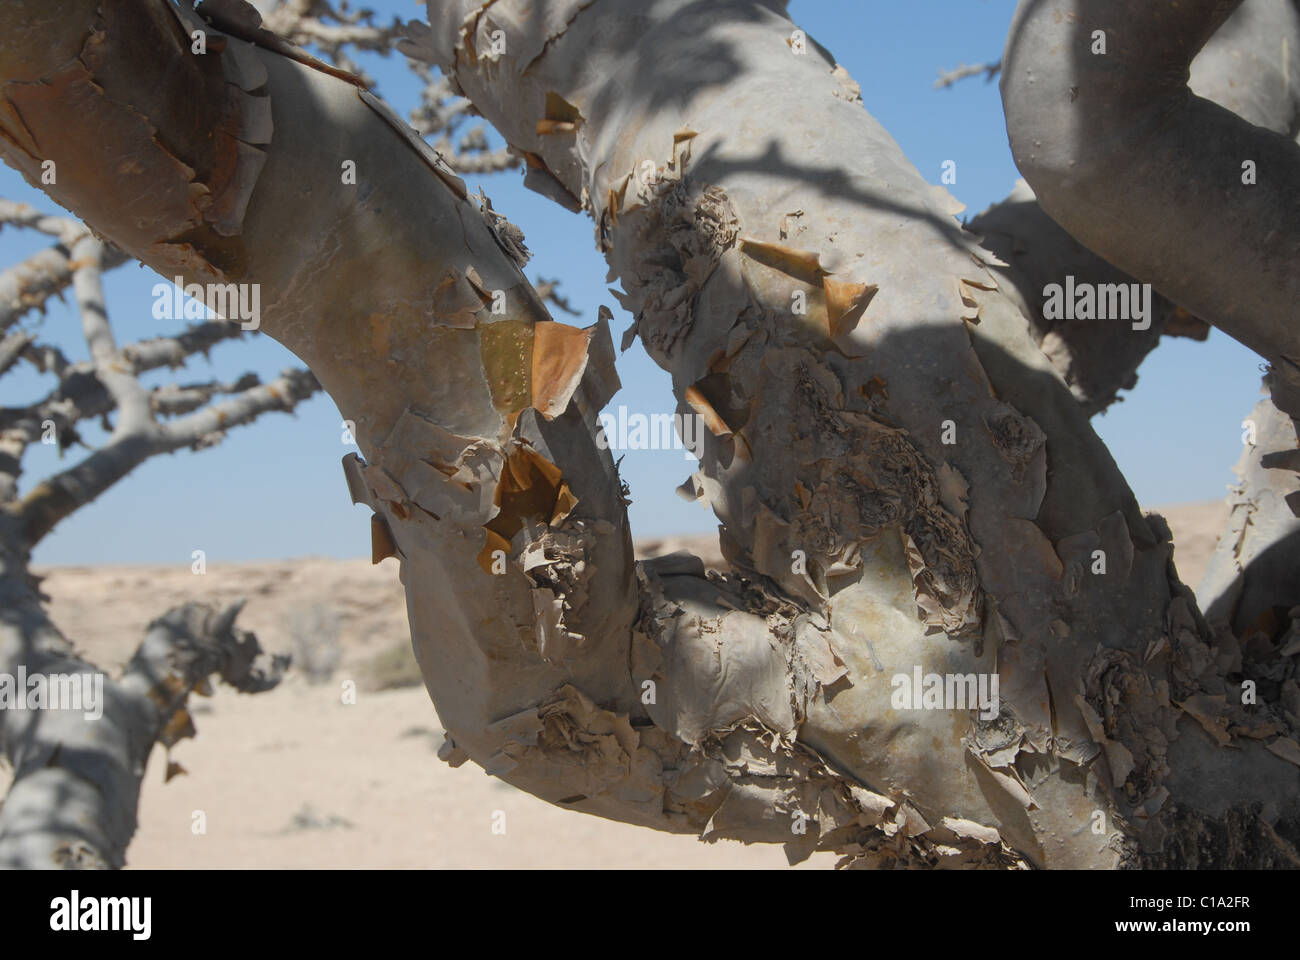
[0,0,1300,868]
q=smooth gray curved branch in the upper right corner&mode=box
[1001,0,1300,415]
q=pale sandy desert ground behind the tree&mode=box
[0,502,1226,869]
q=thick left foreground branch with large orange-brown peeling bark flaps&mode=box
[0,0,650,853]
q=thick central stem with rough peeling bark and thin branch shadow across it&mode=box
[429,0,1296,866]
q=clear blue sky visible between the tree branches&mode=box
[0,0,1260,566]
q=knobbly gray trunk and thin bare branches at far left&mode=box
[0,5,330,868]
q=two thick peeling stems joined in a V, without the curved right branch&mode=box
[0,0,1300,868]
